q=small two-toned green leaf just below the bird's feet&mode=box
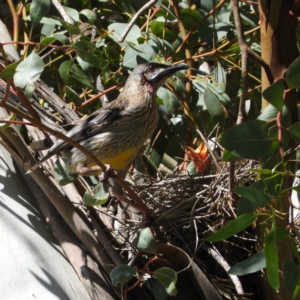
[82,181,110,206]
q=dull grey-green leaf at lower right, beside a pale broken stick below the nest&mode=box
[228,250,266,276]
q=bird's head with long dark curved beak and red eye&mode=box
[124,62,188,94]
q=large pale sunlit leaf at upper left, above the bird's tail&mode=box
[14,51,44,89]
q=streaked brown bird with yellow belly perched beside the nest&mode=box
[31,62,188,198]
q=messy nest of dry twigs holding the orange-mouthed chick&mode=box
[98,160,257,299]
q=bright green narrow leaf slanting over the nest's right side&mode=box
[208,214,259,242]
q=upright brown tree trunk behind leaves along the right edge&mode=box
[256,0,298,299]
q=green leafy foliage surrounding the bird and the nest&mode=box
[0,0,300,298]
